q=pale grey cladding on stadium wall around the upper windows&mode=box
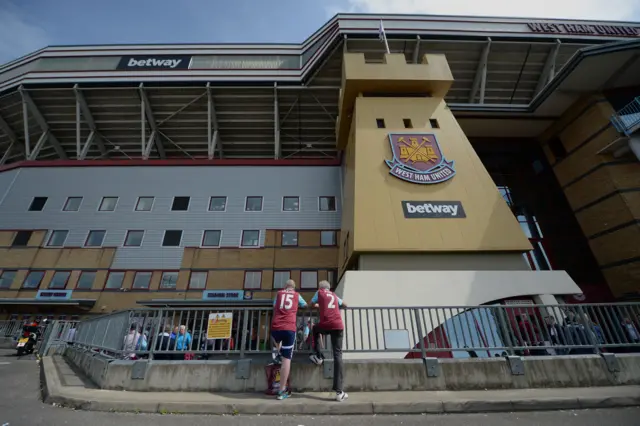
[0,166,340,269]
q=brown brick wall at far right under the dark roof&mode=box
[542,96,640,297]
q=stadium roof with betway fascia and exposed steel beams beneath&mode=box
[0,15,640,165]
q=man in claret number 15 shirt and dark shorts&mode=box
[271,280,307,400]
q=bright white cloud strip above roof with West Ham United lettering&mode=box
[338,0,640,20]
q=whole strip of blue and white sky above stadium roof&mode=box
[0,0,640,64]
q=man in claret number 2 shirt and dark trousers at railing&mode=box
[309,281,349,402]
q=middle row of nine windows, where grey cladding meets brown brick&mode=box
[11,229,336,247]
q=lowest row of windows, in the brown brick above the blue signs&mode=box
[0,270,335,290]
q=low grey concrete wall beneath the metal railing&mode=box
[66,349,640,392]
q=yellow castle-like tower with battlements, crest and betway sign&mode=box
[336,53,531,272]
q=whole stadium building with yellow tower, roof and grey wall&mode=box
[0,15,640,319]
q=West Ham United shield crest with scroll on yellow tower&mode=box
[385,133,456,184]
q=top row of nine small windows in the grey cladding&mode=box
[29,196,336,212]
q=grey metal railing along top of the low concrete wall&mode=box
[74,303,640,359]
